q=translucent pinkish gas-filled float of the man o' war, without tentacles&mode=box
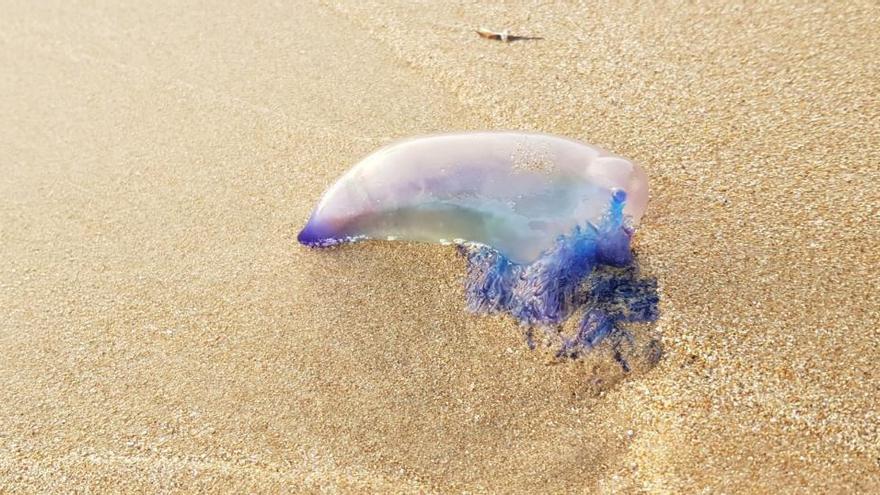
[299,132,648,263]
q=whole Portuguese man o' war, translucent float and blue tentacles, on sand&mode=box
[298,132,657,368]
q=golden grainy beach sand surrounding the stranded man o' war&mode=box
[0,0,880,493]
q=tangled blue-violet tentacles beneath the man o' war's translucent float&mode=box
[459,194,659,371]
